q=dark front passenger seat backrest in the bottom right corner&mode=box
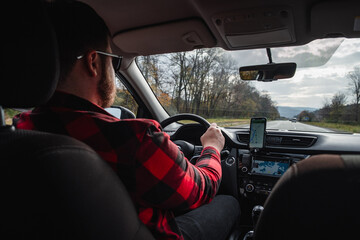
[255,155,360,240]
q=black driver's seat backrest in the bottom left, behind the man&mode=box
[0,130,153,239]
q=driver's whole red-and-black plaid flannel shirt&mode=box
[14,92,222,239]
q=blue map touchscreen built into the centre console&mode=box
[251,159,289,177]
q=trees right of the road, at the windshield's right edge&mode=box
[298,66,360,124]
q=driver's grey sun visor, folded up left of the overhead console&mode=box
[113,19,216,56]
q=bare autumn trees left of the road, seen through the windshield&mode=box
[137,49,279,119]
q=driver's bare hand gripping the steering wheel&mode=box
[200,123,225,153]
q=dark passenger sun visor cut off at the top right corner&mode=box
[311,1,360,37]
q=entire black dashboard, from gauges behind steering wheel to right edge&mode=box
[165,124,360,204]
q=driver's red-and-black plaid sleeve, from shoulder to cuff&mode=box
[136,122,222,210]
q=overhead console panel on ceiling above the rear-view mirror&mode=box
[212,7,296,49]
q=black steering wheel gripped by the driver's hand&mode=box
[160,113,226,163]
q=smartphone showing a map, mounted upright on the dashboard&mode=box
[249,118,266,153]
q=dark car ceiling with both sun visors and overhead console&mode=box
[82,0,360,57]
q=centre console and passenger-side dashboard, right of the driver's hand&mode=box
[232,129,360,203]
